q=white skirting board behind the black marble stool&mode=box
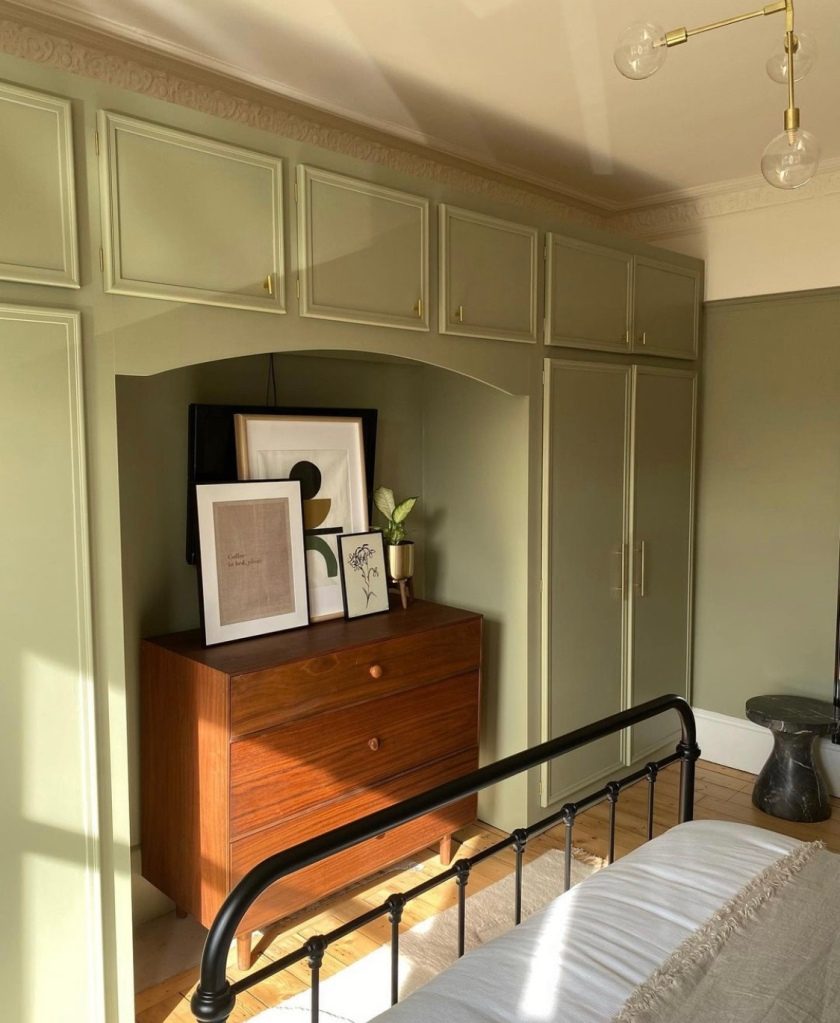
[694,708,840,796]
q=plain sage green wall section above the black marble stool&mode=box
[694,292,840,717]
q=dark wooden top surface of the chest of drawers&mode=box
[143,601,481,675]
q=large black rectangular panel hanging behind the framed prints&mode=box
[185,403,379,565]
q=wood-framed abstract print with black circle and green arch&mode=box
[234,413,368,621]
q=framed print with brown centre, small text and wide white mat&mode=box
[195,480,309,647]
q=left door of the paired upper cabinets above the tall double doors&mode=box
[545,234,632,352]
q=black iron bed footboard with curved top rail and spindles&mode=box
[191,696,700,1023]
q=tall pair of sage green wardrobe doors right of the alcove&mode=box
[542,360,697,803]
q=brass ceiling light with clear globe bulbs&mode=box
[614,0,820,188]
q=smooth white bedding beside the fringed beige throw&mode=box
[368,820,799,1023]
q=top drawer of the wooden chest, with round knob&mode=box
[230,618,481,737]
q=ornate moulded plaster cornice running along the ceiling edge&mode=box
[0,0,840,239]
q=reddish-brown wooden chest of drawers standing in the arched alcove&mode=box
[140,601,481,949]
